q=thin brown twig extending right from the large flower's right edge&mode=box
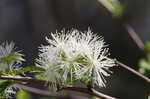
[114,60,150,84]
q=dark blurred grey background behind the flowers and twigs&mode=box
[0,0,150,99]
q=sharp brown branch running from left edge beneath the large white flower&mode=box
[0,76,117,99]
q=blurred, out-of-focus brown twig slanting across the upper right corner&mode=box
[98,0,145,51]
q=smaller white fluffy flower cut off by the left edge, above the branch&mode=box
[0,42,24,72]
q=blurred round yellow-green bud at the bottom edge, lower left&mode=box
[16,90,31,99]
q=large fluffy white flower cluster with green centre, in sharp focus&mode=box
[37,29,115,87]
